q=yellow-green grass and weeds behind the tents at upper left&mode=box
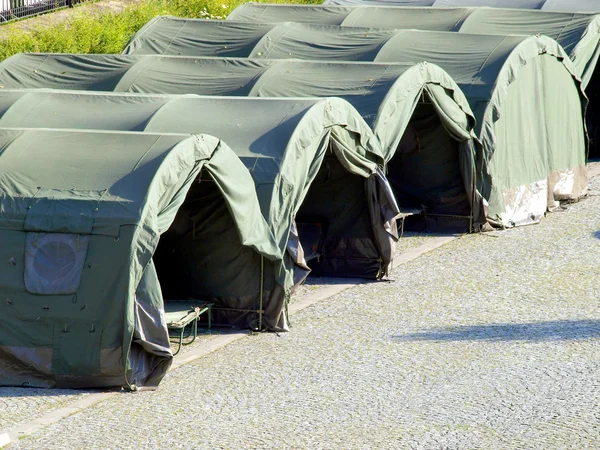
[0,0,321,61]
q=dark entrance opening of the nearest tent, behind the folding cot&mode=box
[153,173,274,325]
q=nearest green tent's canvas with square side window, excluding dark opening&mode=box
[0,129,283,389]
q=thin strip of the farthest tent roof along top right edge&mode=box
[323,0,600,12]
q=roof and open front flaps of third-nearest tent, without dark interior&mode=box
[0,54,485,229]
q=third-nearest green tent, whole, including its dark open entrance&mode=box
[0,54,485,230]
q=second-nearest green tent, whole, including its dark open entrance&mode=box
[0,90,399,292]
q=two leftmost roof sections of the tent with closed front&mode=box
[123,16,395,61]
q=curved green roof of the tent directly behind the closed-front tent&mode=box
[227,3,600,86]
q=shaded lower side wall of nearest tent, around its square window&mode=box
[0,226,140,388]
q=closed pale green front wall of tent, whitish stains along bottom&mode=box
[482,50,586,226]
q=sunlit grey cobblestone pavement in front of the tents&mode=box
[0,171,600,449]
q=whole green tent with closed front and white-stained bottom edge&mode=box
[125,17,587,227]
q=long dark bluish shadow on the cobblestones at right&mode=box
[392,320,600,342]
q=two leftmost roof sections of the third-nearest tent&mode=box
[0,53,268,96]
